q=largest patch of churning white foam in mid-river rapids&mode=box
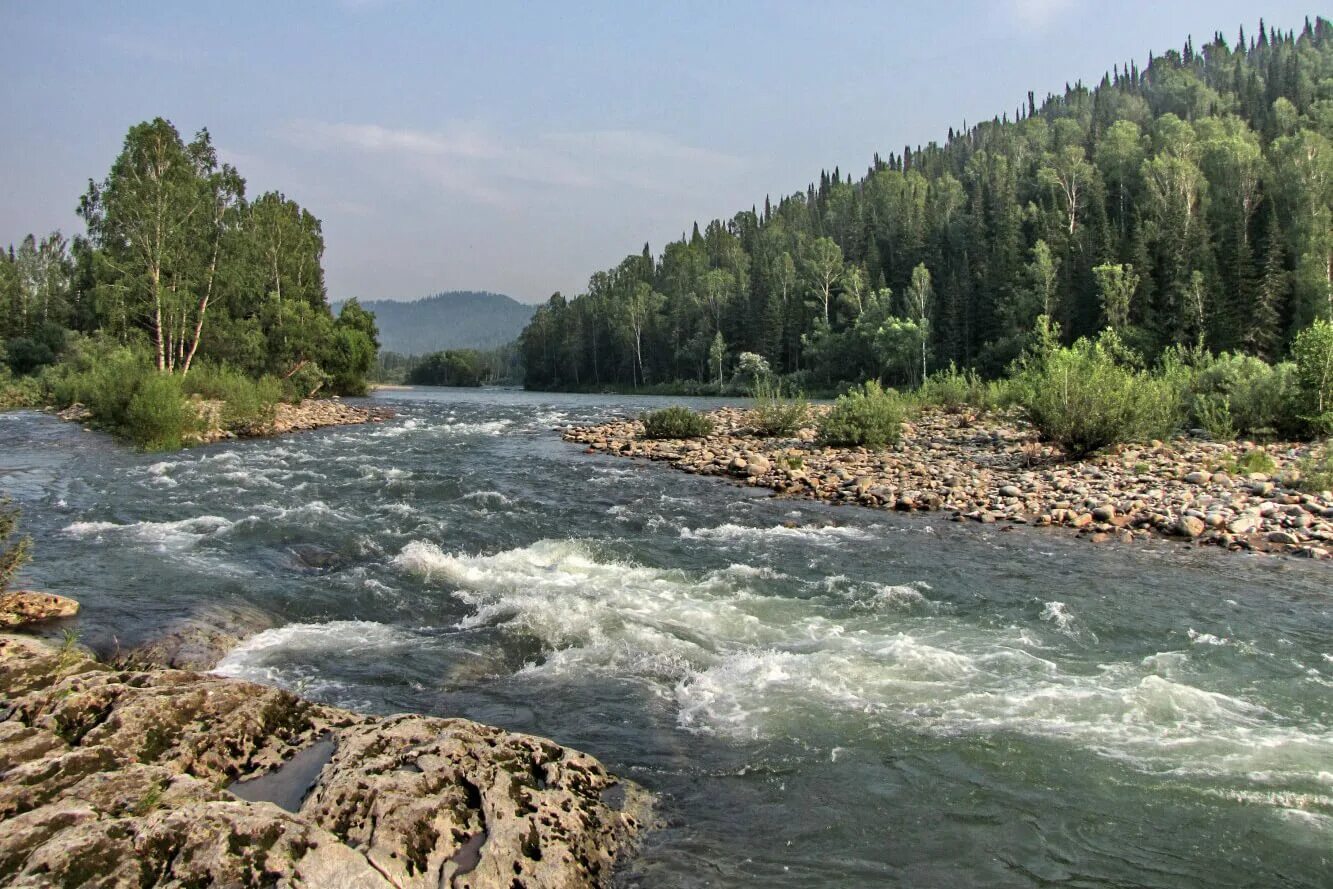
[393,529,1333,799]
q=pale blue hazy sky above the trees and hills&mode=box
[0,0,1317,303]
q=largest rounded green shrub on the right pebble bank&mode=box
[1013,331,1182,457]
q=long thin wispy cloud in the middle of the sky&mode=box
[281,120,744,205]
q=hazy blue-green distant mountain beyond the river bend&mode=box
[333,291,537,355]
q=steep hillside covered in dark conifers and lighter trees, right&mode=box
[517,19,1333,387]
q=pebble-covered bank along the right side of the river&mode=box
[564,408,1333,558]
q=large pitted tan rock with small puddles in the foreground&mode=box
[0,636,647,889]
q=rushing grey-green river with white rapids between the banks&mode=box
[0,389,1333,889]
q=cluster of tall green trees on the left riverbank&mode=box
[0,119,379,393]
